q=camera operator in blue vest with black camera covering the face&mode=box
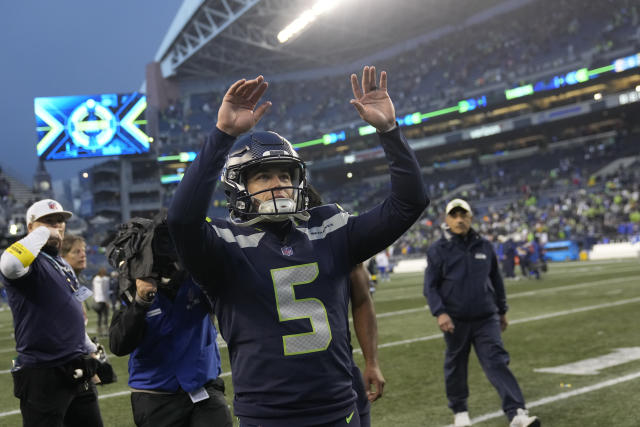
[108,217,232,427]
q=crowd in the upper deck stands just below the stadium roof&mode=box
[156,0,640,151]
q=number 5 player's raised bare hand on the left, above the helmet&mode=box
[216,76,271,136]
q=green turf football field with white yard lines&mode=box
[0,260,640,427]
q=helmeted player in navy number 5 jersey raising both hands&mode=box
[168,67,428,427]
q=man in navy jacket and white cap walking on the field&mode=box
[424,199,540,427]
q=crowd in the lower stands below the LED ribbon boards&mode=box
[0,127,640,275]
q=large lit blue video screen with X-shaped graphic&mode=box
[34,92,151,160]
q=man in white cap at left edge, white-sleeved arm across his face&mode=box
[0,199,102,427]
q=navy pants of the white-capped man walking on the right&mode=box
[444,314,525,419]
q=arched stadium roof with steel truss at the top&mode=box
[155,0,510,79]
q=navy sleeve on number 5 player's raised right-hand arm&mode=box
[348,126,429,265]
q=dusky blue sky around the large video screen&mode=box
[0,0,182,185]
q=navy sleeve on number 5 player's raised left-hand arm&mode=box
[167,128,235,293]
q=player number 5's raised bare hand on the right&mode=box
[351,66,396,133]
